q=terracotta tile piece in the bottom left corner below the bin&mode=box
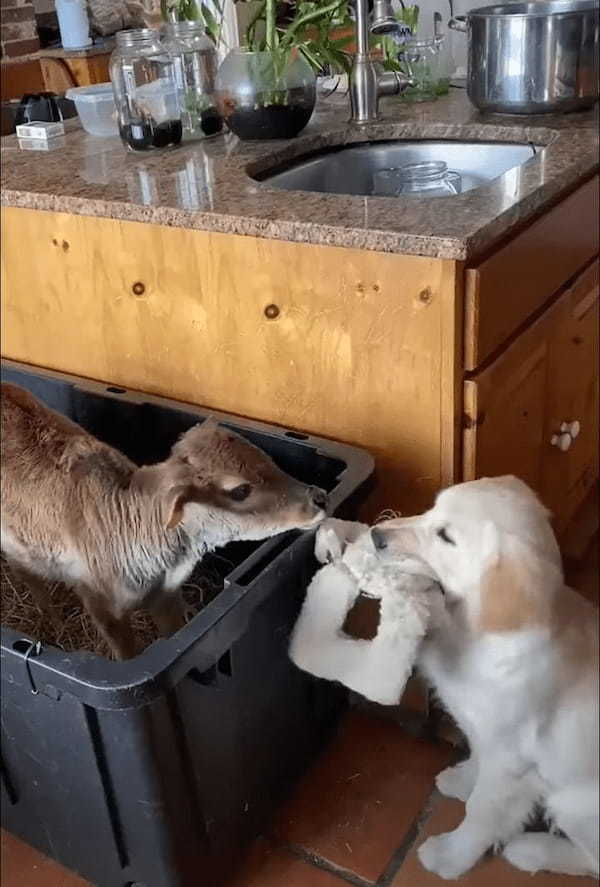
[0,831,91,887]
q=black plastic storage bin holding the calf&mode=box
[1,361,373,887]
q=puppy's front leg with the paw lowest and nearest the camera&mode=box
[419,756,539,880]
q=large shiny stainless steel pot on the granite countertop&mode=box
[448,0,600,114]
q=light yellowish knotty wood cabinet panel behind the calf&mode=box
[2,209,462,516]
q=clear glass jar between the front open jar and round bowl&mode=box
[163,21,223,138]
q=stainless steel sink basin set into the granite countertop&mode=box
[255,140,542,199]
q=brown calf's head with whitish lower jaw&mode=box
[133,420,327,544]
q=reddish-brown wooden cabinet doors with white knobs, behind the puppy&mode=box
[463,261,599,530]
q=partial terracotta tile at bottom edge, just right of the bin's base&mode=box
[227,838,347,887]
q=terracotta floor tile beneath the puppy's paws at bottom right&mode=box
[392,798,598,887]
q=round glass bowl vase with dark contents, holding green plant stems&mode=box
[217,49,317,139]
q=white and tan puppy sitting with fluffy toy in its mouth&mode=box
[372,477,600,879]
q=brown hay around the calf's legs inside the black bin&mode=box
[0,554,233,657]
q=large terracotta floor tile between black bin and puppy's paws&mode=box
[273,712,451,881]
